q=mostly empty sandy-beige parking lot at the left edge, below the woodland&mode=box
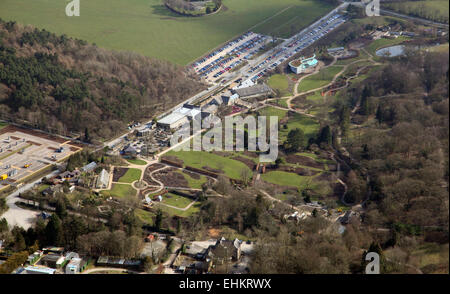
[0,126,81,184]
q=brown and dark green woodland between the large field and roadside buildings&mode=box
[0,21,203,138]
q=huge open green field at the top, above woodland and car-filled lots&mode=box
[0,0,333,65]
